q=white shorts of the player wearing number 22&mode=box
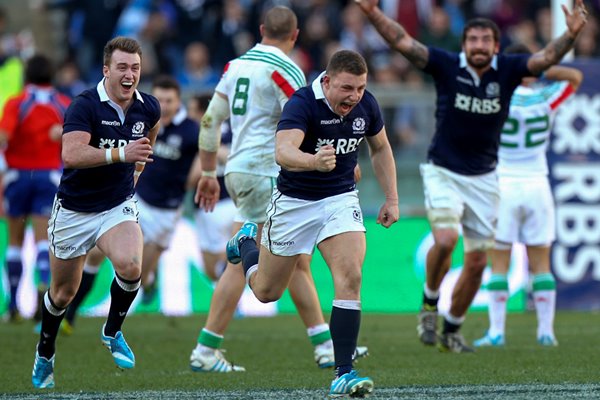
[496,176,556,246]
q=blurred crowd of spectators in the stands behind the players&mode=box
[0,0,600,155]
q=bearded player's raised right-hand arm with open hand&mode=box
[527,0,587,75]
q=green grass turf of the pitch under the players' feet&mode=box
[0,312,600,399]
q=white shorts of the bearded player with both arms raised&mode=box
[420,163,500,251]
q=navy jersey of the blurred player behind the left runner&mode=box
[135,108,200,209]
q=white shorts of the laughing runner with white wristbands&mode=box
[48,197,138,260]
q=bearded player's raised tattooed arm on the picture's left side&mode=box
[355,0,429,68]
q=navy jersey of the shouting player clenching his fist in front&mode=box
[277,74,383,200]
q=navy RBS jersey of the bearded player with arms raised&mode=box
[424,47,532,175]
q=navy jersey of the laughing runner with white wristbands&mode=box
[57,80,160,212]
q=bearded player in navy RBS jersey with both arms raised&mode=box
[355,0,587,353]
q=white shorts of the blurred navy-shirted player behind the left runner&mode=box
[135,196,181,249]
